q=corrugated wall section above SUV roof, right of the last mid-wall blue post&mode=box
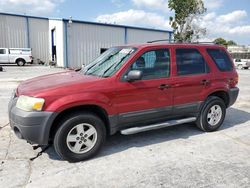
[127,28,169,43]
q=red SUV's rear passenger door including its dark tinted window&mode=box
[173,48,211,115]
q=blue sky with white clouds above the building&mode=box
[0,0,250,44]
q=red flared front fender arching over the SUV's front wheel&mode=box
[44,93,113,114]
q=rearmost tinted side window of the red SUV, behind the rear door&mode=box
[207,49,233,72]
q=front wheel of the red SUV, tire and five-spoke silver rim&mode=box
[54,113,106,162]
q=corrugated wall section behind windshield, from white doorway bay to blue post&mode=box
[67,22,125,67]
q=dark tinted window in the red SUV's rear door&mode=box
[176,48,209,75]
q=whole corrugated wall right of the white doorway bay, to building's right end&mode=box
[67,21,172,67]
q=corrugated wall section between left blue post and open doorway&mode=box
[28,18,49,63]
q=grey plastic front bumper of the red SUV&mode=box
[9,97,56,145]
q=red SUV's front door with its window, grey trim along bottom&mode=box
[113,49,173,124]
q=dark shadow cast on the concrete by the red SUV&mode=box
[46,108,250,160]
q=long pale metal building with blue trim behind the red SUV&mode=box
[0,13,172,67]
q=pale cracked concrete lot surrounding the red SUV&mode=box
[0,66,250,188]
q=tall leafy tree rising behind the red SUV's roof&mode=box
[168,0,206,42]
